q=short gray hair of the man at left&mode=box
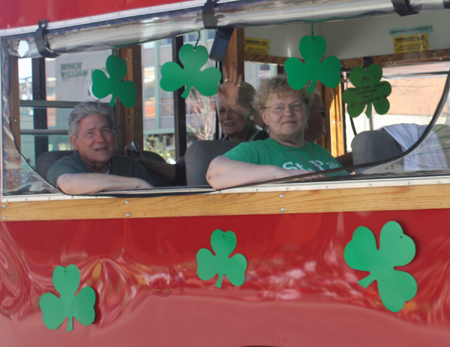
[69,101,114,138]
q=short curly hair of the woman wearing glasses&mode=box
[253,75,314,118]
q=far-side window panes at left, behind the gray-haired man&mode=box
[19,50,111,168]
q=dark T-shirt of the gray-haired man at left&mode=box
[47,151,153,186]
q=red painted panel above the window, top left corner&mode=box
[0,0,190,29]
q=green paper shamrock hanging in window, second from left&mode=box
[160,44,222,98]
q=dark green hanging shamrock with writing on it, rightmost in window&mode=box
[343,64,391,118]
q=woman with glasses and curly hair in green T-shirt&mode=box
[206,76,341,189]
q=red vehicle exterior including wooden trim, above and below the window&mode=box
[0,0,450,347]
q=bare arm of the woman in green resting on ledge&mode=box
[206,156,314,189]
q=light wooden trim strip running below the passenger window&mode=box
[0,184,450,221]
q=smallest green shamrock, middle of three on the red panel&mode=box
[197,229,247,288]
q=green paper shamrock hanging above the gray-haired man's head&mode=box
[92,55,137,107]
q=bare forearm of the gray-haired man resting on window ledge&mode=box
[56,173,153,195]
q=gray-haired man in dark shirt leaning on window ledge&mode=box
[47,102,152,195]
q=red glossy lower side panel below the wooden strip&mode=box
[0,210,450,347]
